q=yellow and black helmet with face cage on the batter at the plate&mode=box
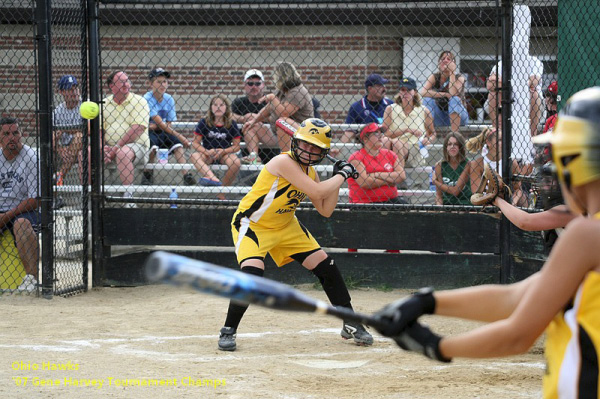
[292,118,331,166]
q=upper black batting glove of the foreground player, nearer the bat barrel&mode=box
[375,287,435,337]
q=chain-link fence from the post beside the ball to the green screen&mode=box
[89,1,557,211]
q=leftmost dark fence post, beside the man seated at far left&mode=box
[35,0,54,299]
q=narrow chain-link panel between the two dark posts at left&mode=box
[51,0,90,294]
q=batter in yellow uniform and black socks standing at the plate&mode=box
[219,119,373,351]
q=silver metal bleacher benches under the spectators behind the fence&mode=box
[50,125,483,257]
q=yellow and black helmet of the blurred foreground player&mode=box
[535,86,600,212]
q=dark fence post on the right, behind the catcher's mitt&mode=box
[499,0,513,284]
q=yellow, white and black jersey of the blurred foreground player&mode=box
[544,213,600,399]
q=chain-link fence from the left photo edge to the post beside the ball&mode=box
[0,0,88,295]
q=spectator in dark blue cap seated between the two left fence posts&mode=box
[52,75,83,189]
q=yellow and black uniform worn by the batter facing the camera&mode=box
[231,152,320,266]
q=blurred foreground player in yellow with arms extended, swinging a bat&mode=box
[378,87,600,399]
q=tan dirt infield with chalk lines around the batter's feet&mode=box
[0,286,544,399]
